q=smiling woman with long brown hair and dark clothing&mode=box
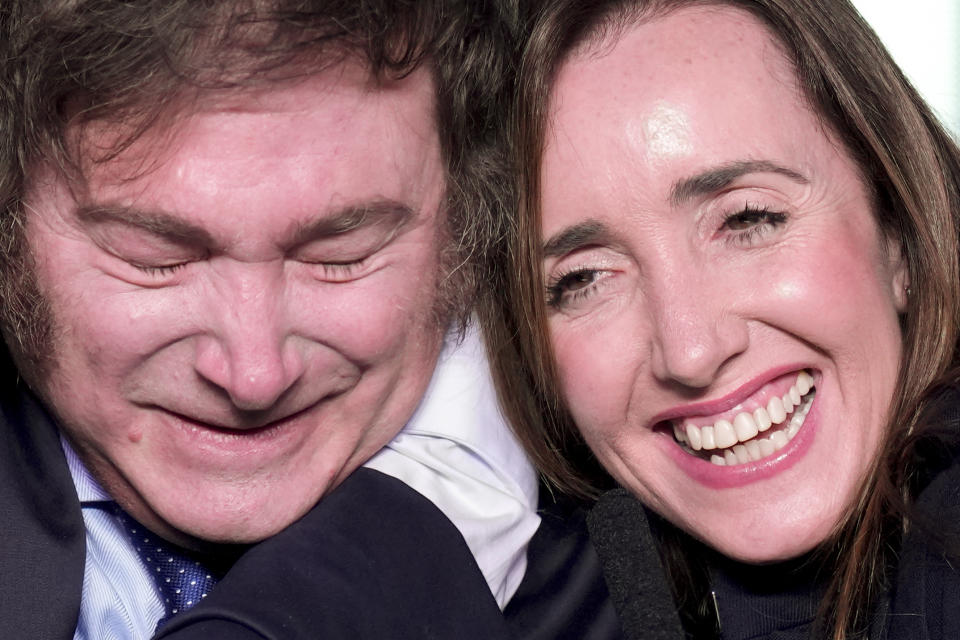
[501,0,960,638]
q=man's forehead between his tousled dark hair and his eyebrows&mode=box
[31,58,446,250]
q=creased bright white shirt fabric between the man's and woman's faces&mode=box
[364,327,540,609]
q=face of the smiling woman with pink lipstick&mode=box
[542,7,907,562]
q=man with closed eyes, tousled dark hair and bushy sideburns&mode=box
[0,0,568,638]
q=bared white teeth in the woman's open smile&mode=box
[671,371,817,466]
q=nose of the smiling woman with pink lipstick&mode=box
[647,272,749,389]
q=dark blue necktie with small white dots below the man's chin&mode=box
[116,507,221,629]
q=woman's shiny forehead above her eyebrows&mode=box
[543,7,820,209]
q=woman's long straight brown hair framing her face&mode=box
[498,0,960,640]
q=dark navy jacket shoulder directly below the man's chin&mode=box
[160,468,506,640]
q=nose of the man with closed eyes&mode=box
[195,265,304,411]
